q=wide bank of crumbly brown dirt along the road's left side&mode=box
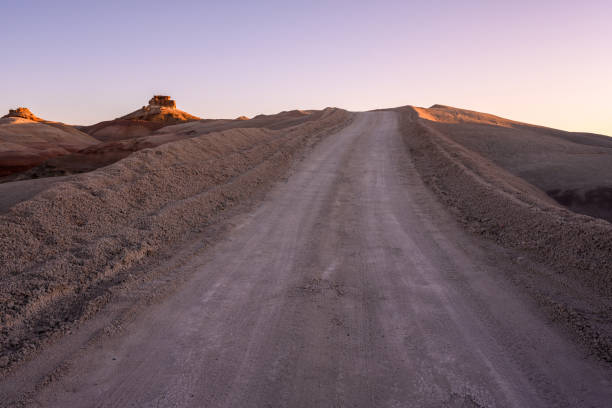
[0,109,351,372]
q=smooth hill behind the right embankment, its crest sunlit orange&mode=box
[414,105,612,221]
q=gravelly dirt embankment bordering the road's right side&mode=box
[396,106,612,361]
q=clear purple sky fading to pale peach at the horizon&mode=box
[0,0,612,135]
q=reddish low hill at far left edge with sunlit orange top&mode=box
[0,116,98,177]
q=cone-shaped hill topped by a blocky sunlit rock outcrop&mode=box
[81,95,200,142]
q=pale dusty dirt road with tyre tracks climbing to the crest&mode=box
[9,112,612,407]
